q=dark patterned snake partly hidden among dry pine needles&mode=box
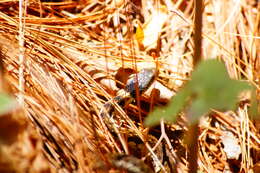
[98,68,157,173]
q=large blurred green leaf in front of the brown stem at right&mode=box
[145,60,251,126]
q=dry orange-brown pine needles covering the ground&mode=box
[0,0,260,172]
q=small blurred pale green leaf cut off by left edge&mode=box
[0,93,16,114]
